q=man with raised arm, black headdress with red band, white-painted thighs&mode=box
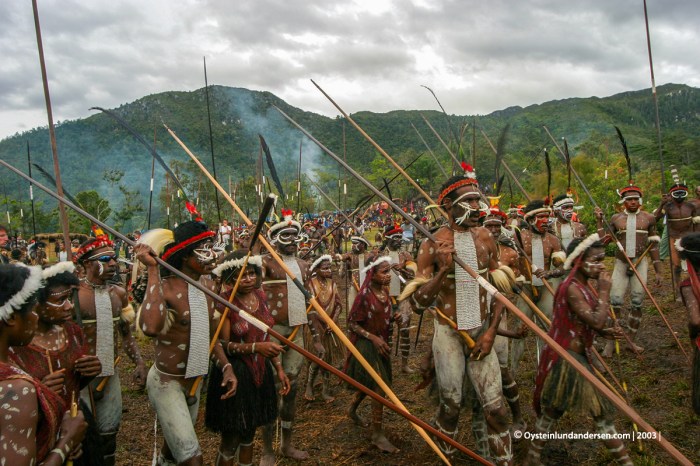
[134,220,237,466]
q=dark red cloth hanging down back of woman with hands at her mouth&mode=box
[533,273,598,415]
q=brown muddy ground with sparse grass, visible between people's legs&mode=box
[117,260,700,466]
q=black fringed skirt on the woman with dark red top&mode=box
[204,358,277,438]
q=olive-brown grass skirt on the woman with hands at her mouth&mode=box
[540,351,615,418]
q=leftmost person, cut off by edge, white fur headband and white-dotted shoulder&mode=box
[0,265,87,466]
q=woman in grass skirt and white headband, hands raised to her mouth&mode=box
[527,237,633,465]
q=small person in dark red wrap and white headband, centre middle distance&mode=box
[345,256,398,453]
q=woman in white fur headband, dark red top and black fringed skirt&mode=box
[205,251,290,466]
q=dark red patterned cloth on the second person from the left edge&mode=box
[8,322,89,406]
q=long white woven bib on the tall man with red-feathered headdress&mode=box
[454,231,481,330]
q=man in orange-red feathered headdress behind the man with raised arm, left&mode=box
[73,229,146,466]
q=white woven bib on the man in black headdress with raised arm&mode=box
[185,283,209,379]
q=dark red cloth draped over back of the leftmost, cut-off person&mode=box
[0,362,66,458]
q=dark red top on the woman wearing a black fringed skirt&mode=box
[217,290,275,387]
